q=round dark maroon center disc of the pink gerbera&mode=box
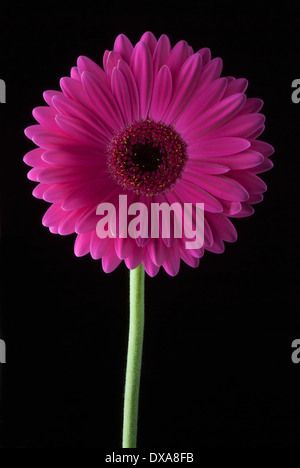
[108,120,186,196]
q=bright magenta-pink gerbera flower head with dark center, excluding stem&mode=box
[24,32,273,276]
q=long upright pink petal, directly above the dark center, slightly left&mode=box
[130,42,153,119]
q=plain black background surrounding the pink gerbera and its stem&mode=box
[0,1,300,451]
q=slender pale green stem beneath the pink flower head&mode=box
[122,264,145,448]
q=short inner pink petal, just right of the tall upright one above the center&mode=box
[149,65,172,121]
